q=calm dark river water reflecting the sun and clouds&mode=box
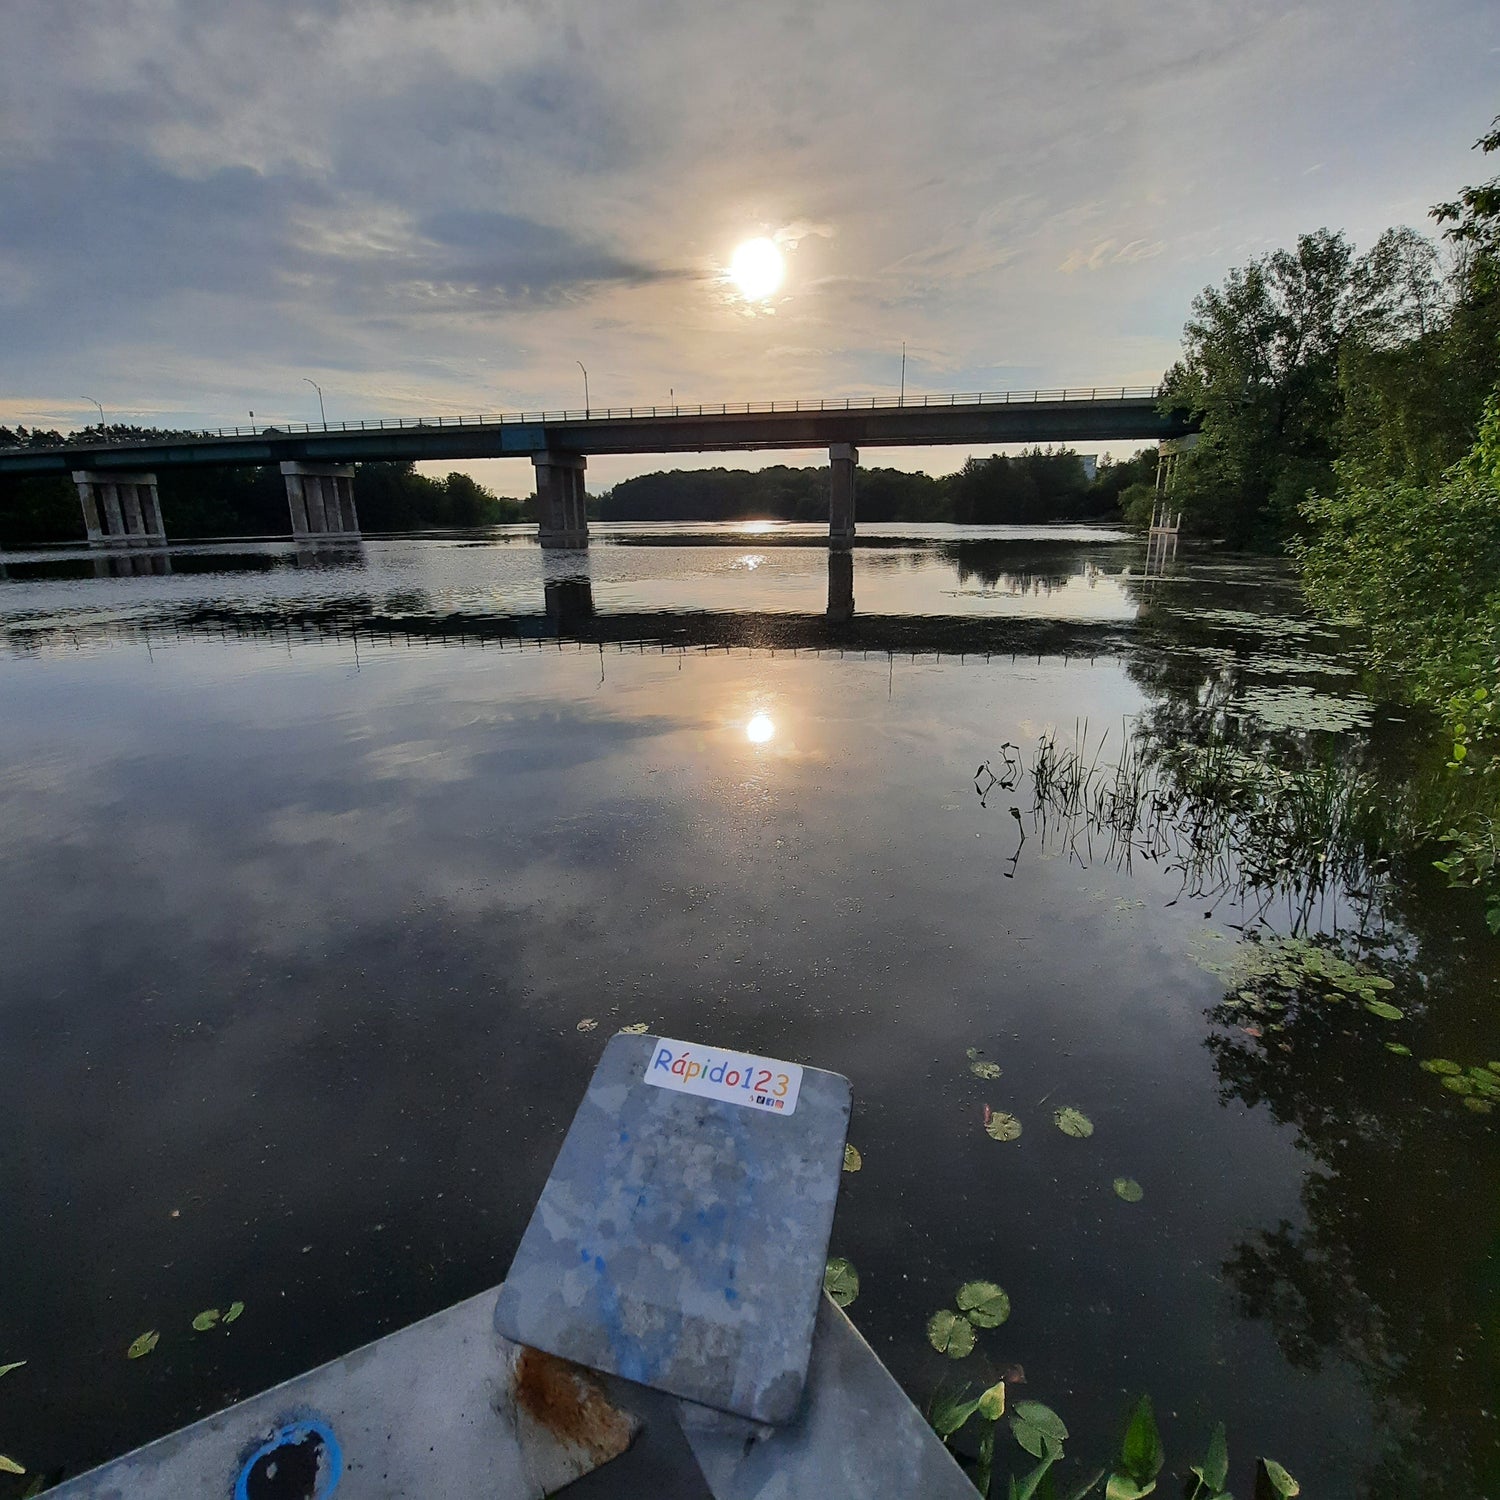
[0,525,1500,1500]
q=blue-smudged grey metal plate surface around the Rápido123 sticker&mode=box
[495,1035,851,1422]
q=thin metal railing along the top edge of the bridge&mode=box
[0,386,1161,452]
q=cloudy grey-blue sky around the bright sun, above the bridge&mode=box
[0,0,1500,494]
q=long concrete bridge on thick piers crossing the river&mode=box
[0,386,1196,548]
